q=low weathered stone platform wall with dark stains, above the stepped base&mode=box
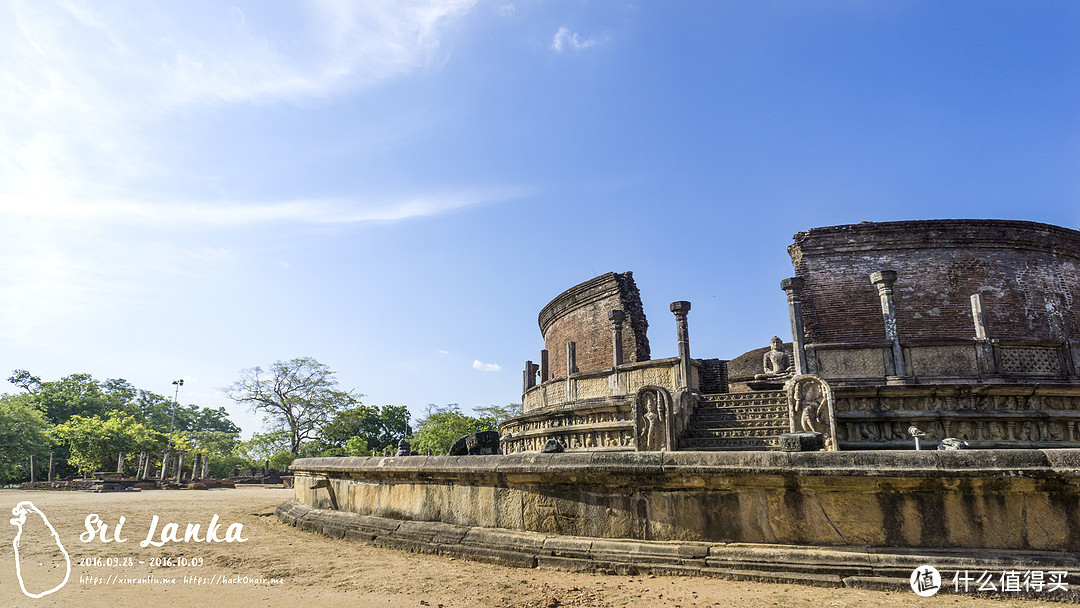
[292,449,1080,553]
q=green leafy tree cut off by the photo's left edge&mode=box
[0,393,52,485]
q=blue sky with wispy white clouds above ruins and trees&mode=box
[0,0,1080,434]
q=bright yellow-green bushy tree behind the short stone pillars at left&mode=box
[51,410,171,473]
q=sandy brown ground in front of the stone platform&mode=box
[0,487,1062,608]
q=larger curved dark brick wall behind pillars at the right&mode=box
[788,220,1080,343]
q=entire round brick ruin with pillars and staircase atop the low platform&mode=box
[500,220,1080,452]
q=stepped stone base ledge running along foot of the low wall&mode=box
[276,500,1080,602]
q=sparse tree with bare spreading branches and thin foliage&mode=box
[222,356,360,456]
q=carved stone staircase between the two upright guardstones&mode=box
[679,391,788,450]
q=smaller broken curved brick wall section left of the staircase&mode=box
[539,272,649,381]
